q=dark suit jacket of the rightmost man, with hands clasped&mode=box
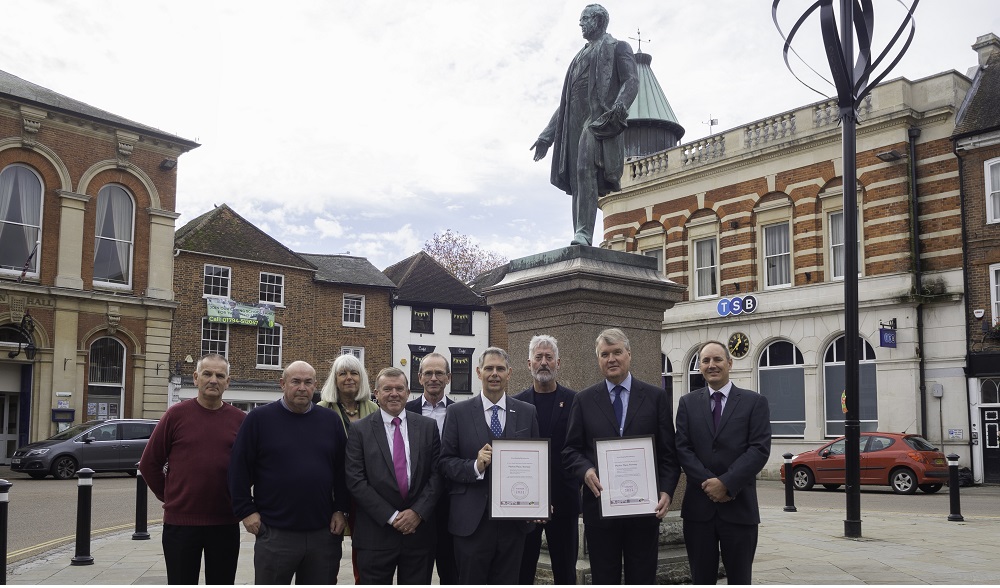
[677,385,771,525]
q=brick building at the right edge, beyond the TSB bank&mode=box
[952,34,1000,484]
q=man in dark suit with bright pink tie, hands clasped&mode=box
[346,368,442,584]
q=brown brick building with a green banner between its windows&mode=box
[170,204,395,410]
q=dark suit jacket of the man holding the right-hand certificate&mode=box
[563,376,680,525]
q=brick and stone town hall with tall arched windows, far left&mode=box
[0,72,198,454]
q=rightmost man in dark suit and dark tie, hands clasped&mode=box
[677,341,771,584]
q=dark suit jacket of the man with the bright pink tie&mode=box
[345,410,443,549]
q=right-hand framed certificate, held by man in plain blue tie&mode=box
[594,436,660,518]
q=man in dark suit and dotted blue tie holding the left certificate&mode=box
[441,347,538,584]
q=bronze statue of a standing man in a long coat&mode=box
[531,4,639,245]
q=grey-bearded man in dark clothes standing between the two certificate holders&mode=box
[514,335,580,584]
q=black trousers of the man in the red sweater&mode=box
[163,523,240,585]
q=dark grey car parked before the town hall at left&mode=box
[10,419,156,480]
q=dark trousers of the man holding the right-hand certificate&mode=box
[584,516,660,585]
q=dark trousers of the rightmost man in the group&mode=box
[684,516,757,585]
